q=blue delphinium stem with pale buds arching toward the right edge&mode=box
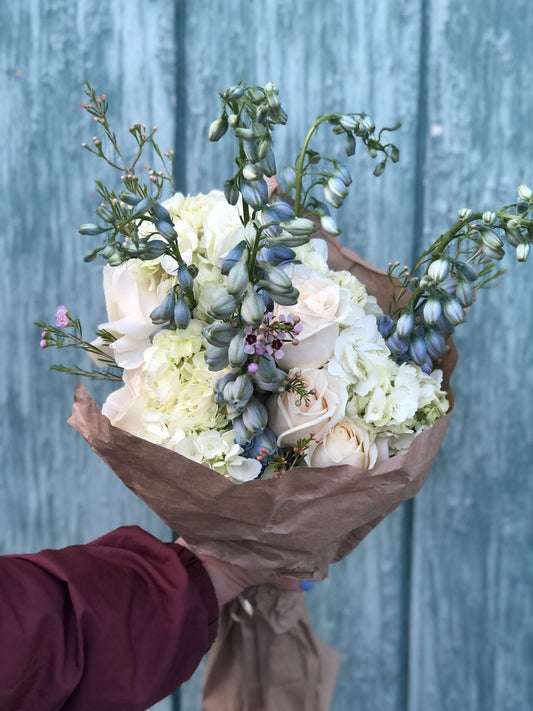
[379,185,533,372]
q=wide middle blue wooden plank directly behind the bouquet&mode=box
[178,0,421,711]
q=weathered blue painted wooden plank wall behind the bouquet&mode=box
[0,0,533,711]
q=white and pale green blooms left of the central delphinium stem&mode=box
[101,191,261,481]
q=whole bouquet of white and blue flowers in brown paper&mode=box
[39,84,533,711]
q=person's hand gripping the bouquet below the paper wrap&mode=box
[176,538,306,607]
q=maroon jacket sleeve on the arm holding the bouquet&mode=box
[0,526,218,711]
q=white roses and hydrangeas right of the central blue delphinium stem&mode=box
[268,240,448,469]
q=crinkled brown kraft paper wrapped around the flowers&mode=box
[69,220,457,711]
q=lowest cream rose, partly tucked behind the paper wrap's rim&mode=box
[310,417,378,470]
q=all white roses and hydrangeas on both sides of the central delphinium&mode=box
[99,191,448,481]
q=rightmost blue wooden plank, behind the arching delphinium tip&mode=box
[409,0,533,711]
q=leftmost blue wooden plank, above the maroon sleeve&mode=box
[0,0,179,709]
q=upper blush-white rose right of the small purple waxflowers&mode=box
[274,264,350,370]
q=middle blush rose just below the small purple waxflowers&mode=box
[267,368,348,447]
